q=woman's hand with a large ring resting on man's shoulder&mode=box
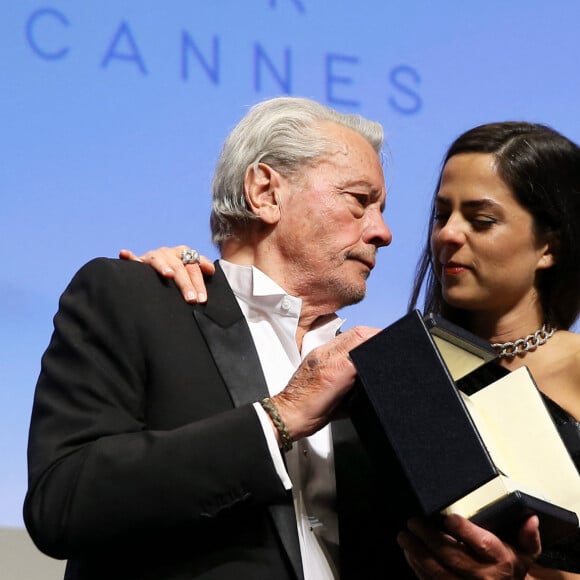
[119,245,215,303]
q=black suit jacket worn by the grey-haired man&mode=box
[24,259,408,580]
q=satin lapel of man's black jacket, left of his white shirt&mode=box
[193,262,303,579]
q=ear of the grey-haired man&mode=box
[244,163,283,225]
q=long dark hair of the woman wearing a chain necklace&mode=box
[409,121,580,329]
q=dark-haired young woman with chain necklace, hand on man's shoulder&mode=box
[121,122,580,580]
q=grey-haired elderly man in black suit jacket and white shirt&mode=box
[24,98,540,580]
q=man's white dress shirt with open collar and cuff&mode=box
[220,260,344,580]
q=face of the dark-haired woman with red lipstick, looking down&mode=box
[431,153,553,312]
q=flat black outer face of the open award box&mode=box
[350,311,498,515]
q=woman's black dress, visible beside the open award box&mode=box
[538,395,580,573]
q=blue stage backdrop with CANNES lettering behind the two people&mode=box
[0,0,580,580]
